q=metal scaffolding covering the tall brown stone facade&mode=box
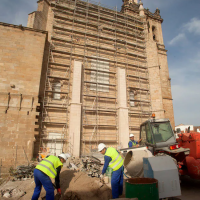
[41,0,150,154]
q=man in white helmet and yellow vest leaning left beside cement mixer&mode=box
[98,143,124,199]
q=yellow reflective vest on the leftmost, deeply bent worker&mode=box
[36,156,63,178]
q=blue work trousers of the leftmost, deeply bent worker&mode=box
[31,169,54,200]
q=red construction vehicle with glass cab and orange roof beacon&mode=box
[122,114,200,179]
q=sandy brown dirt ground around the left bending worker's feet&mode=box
[0,170,112,200]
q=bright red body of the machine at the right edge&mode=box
[177,132,200,179]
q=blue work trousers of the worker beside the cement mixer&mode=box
[111,166,123,199]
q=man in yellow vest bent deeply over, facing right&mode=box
[31,153,68,200]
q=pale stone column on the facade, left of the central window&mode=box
[69,61,82,157]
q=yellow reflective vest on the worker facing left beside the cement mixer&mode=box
[105,147,124,171]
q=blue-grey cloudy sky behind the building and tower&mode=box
[0,0,200,125]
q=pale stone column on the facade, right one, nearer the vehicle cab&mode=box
[117,67,129,148]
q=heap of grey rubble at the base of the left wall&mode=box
[10,164,35,181]
